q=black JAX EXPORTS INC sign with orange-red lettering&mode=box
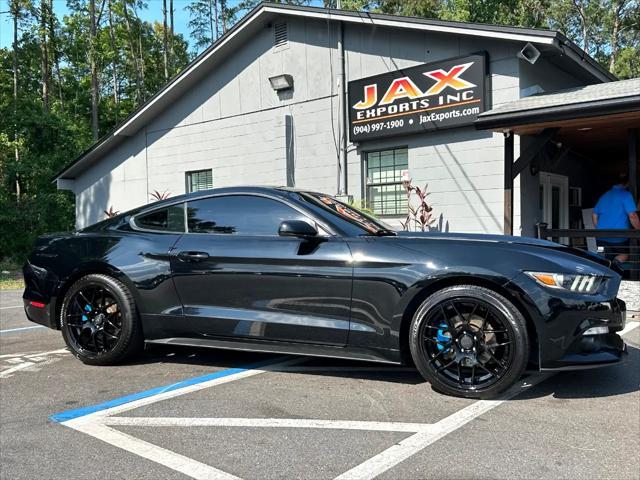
[349,54,486,142]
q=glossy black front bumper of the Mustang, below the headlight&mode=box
[511,276,627,370]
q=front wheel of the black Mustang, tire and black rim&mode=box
[409,285,529,399]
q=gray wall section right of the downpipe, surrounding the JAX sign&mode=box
[345,26,520,233]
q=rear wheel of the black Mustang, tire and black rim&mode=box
[60,274,144,365]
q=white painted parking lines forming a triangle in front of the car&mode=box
[56,322,640,480]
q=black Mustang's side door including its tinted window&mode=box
[171,194,353,345]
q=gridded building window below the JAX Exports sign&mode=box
[365,148,408,215]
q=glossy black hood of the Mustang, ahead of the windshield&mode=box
[397,231,621,273]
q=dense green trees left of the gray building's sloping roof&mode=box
[0,0,190,260]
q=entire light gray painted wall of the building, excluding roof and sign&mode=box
[74,15,584,233]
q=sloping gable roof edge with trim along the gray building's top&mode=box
[54,2,615,181]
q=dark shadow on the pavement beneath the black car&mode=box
[129,345,640,401]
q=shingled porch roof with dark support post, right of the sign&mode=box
[475,78,640,235]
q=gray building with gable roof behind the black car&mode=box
[57,3,615,234]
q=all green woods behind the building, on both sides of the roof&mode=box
[0,0,640,266]
